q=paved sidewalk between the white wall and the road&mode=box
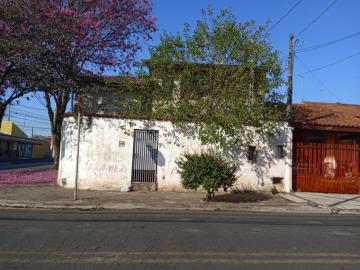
[0,184,360,214]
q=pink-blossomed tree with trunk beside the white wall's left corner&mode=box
[28,0,155,167]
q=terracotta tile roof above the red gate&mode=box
[293,102,360,128]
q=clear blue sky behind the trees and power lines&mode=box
[7,0,360,135]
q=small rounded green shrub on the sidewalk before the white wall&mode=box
[176,153,236,200]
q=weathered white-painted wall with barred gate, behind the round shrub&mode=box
[58,115,292,192]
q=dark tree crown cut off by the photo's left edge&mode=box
[0,0,39,126]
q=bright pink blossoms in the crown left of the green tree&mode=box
[37,0,156,72]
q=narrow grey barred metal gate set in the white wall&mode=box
[131,129,159,183]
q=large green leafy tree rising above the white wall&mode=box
[124,8,283,148]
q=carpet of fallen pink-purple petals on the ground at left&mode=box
[0,170,58,185]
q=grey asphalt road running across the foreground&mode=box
[0,209,360,270]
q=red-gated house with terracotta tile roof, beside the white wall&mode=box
[293,102,360,193]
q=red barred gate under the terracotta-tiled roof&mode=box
[293,143,360,193]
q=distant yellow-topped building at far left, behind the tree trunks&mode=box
[0,121,51,161]
